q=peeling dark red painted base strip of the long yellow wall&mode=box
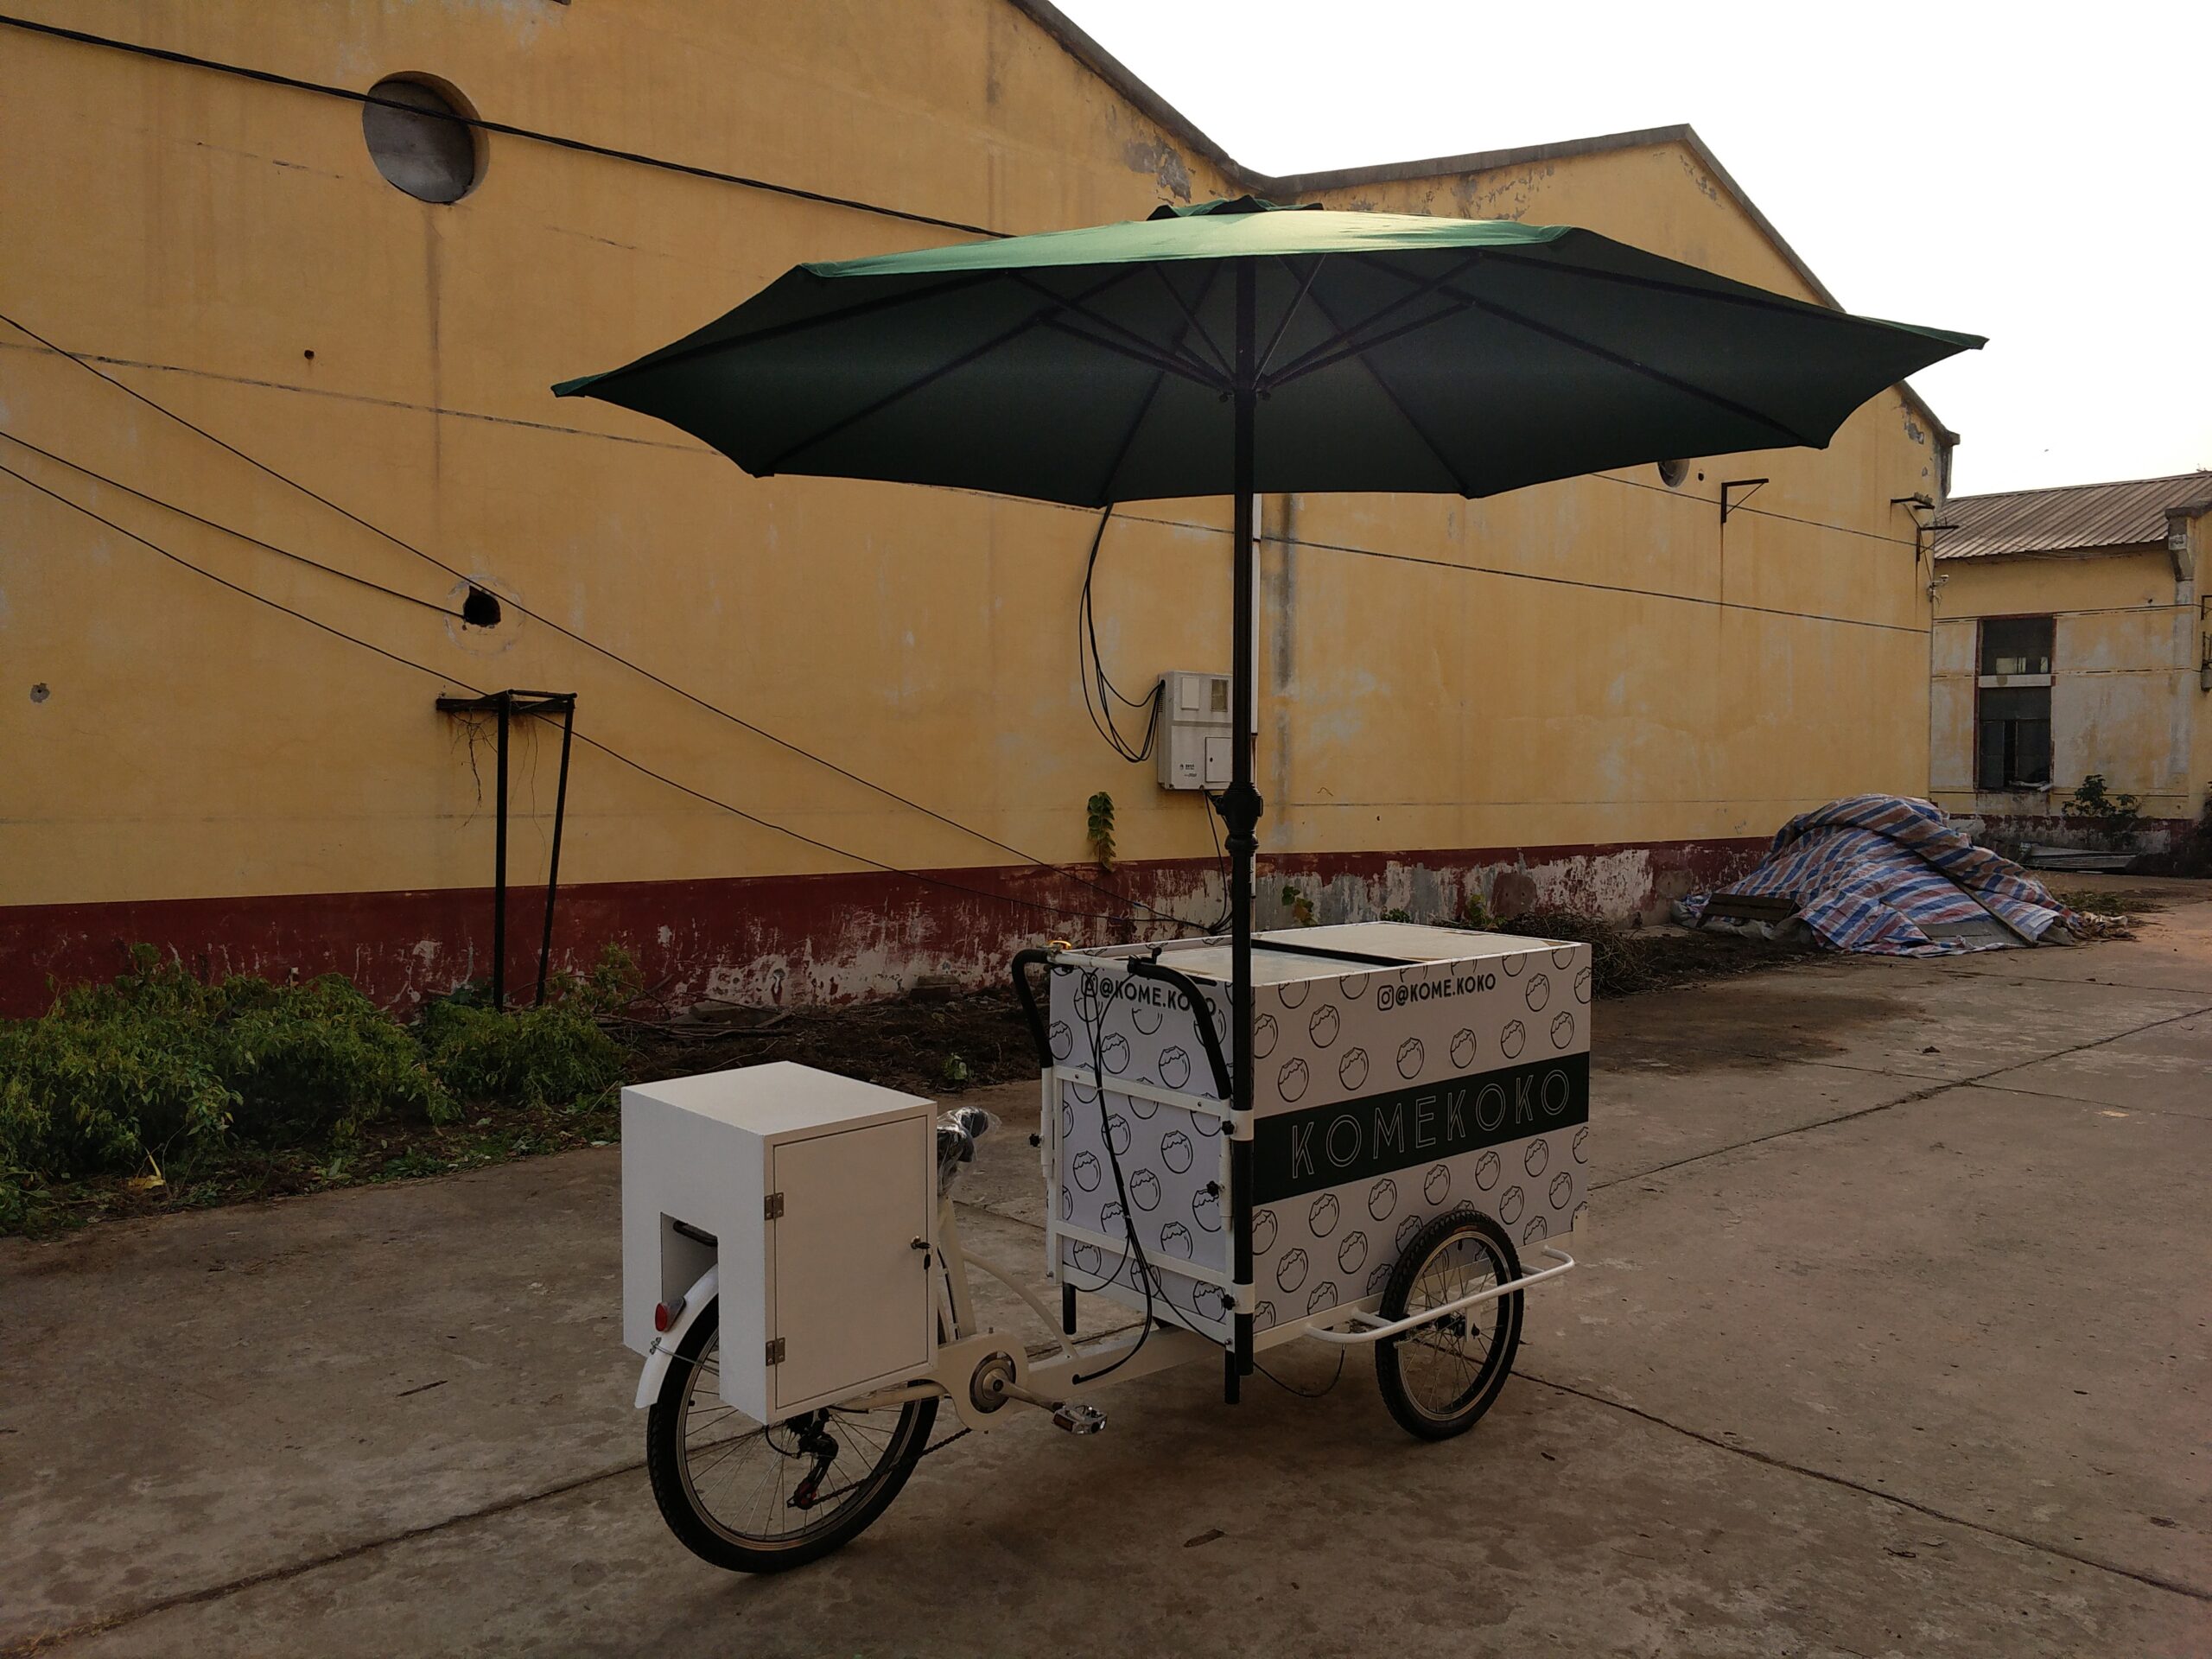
[0,838,1767,1018]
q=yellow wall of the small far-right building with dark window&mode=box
[1929,546,2212,818]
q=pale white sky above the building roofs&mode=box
[1059,0,2212,495]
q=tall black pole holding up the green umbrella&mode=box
[1221,259,1261,1405]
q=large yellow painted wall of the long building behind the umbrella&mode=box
[0,0,1971,986]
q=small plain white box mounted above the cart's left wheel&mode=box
[621,1062,938,1422]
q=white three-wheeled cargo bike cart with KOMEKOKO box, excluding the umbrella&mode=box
[621,923,1591,1573]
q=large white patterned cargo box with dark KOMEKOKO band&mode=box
[1039,923,1591,1347]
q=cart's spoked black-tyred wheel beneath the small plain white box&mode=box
[646,1303,938,1573]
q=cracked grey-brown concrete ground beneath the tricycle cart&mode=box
[0,882,2212,1659]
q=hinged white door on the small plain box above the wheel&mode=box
[770,1115,936,1411]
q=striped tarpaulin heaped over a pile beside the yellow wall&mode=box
[1681,794,2070,956]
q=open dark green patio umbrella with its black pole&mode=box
[556,197,1982,1371]
